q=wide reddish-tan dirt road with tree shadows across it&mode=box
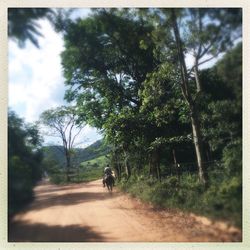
[9,180,241,242]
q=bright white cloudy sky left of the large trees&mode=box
[8,10,102,147]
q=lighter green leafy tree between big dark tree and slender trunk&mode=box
[140,62,193,179]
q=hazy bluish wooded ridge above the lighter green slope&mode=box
[43,140,110,166]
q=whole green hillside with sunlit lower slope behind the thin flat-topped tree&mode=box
[43,140,109,184]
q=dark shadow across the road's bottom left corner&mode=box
[8,221,107,242]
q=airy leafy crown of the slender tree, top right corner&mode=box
[182,8,242,59]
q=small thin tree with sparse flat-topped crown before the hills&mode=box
[40,106,85,181]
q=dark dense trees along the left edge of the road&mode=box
[8,110,43,216]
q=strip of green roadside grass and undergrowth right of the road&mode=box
[118,174,242,228]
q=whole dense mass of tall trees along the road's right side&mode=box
[57,9,241,184]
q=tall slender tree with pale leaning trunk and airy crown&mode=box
[146,9,241,184]
